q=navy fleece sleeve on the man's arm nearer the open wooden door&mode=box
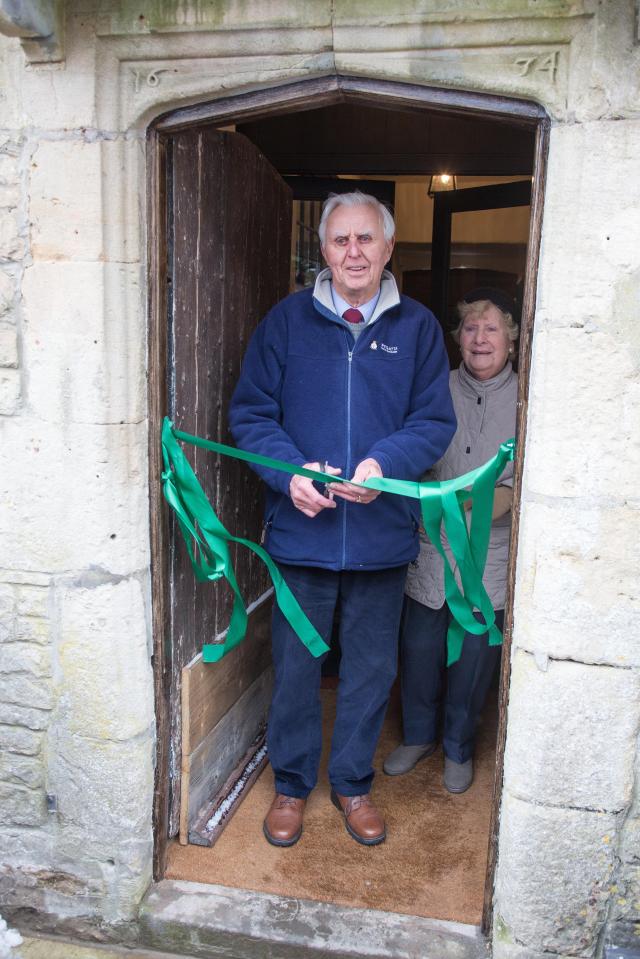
[229,307,306,495]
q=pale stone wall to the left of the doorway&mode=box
[0,1,155,922]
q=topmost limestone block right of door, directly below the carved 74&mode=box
[536,119,640,326]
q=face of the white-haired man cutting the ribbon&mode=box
[322,206,393,306]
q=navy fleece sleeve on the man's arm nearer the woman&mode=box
[367,310,457,480]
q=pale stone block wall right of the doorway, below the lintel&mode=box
[496,109,640,957]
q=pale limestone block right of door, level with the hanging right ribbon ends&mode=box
[514,499,640,666]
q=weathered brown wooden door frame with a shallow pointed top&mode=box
[147,74,550,932]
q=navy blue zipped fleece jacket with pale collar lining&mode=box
[229,271,456,570]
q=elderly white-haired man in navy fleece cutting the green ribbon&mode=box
[229,192,456,846]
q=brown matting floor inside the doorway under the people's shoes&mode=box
[166,689,497,925]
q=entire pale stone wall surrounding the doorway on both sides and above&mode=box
[0,0,640,959]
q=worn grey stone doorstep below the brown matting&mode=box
[139,879,489,959]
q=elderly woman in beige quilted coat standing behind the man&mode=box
[383,287,518,793]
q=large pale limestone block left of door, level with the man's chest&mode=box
[23,262,146,423]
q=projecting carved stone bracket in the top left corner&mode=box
[0,0,64,63]
